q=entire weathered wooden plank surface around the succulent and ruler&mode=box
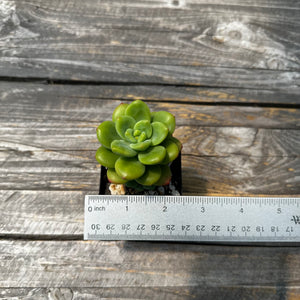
[0,0,300,300]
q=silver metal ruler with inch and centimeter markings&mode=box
[84,195,300,242]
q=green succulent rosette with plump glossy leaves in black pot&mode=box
[96,100,181,187]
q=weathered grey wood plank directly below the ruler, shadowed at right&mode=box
[0,240,300,292]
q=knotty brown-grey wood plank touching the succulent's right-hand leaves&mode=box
[175,126,300,159]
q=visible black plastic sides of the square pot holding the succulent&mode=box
[99,153,182,195]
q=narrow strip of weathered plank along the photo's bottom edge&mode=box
[0,284,300,300]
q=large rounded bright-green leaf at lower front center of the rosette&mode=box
[115,157,146,180]
